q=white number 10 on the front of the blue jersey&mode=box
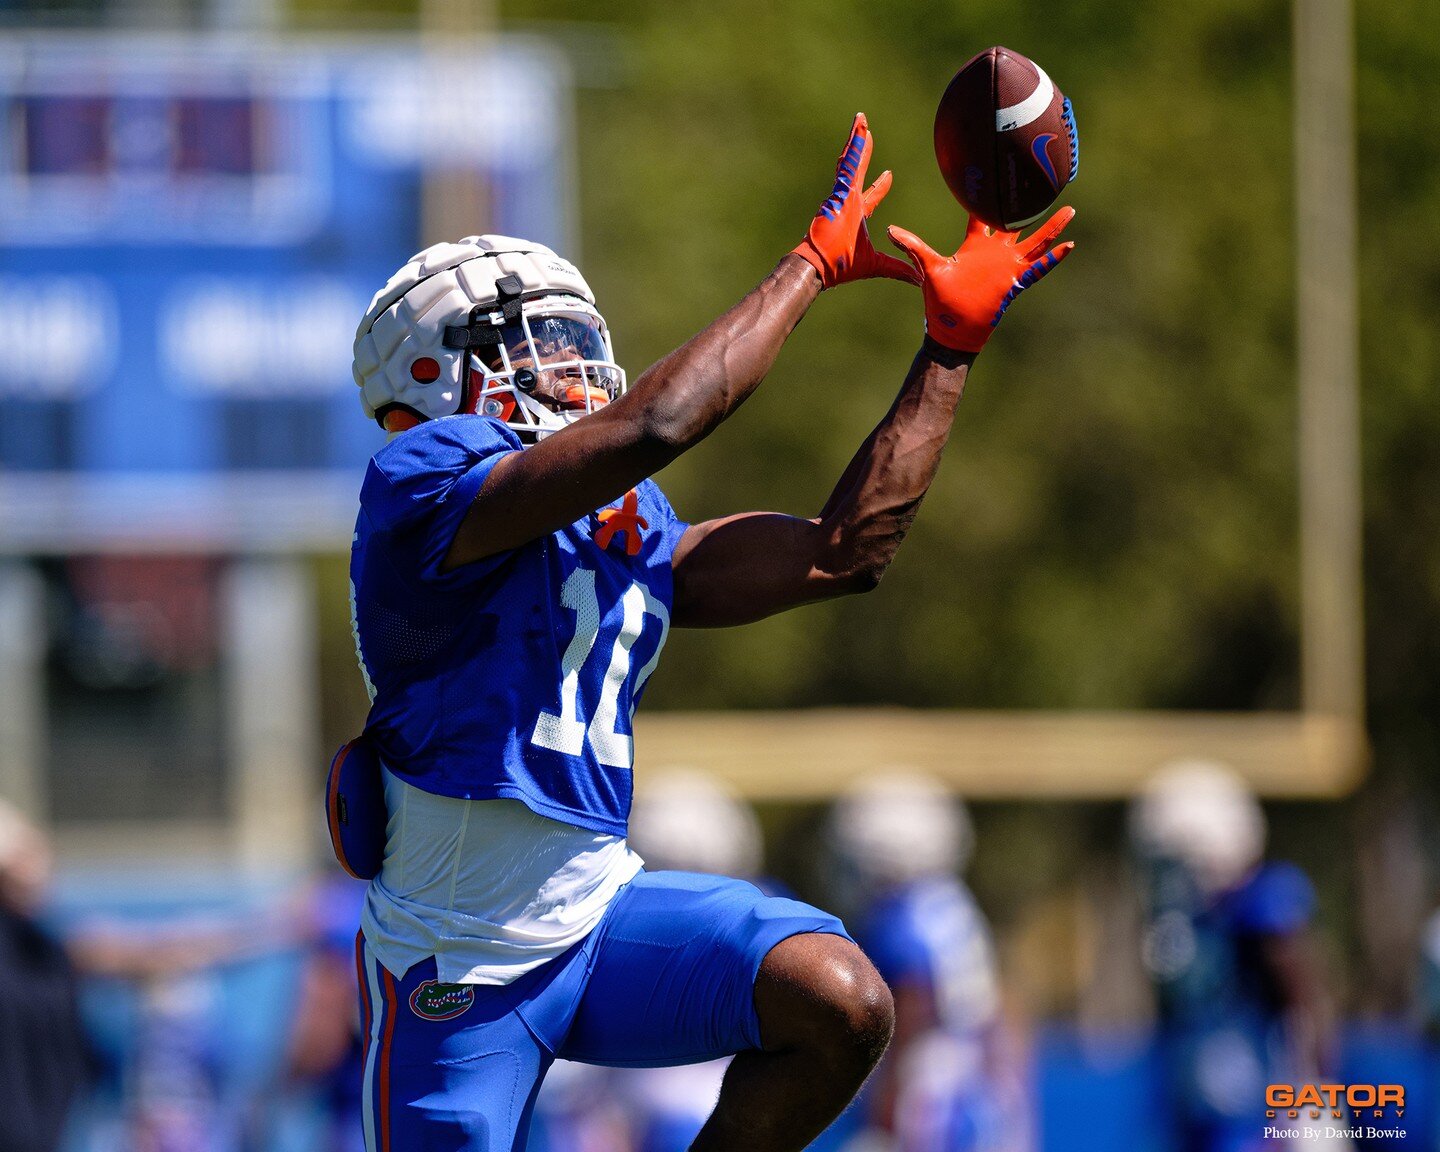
[530,567,670,768]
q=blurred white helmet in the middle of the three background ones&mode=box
[829,769,975,888]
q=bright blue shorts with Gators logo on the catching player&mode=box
[356,873,850,1152]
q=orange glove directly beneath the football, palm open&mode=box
[890,207,1076,351]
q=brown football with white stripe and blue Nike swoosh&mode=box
[935,46,1080,229]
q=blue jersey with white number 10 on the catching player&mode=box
[350,415,685,835]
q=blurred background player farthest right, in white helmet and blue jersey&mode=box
[1130,760,1335,1152]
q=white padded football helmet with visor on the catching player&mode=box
[353,235,625,444]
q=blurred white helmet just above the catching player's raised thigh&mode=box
[629,769,760,880]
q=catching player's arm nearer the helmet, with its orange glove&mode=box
[445,115,919,569]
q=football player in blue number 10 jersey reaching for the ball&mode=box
[351,115,1073,1152]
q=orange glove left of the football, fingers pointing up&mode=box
[795,112,920,288]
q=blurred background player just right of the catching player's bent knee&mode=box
[829,770,1032,1152]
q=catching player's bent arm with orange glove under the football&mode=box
[671,209,1074,628]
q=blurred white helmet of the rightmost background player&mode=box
[1130,760,1266,893]
